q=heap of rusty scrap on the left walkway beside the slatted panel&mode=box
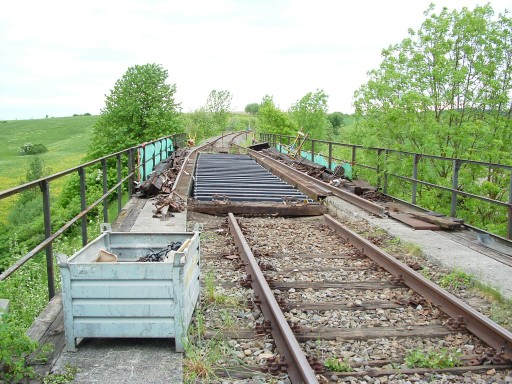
[137,148,190,217]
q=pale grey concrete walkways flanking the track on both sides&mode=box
[28,192,512,384]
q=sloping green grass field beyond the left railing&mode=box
[0,116,99,220]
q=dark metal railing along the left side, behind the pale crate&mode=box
[0,133,186,299]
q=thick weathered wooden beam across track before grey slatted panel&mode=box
[188,201,328,216]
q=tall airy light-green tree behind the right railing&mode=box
[353,5,512,234]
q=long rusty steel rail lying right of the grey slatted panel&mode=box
[242,149,387,217]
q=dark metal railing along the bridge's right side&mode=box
[260,133,512,239]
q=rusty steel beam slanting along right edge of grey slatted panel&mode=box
[248,150,387,217]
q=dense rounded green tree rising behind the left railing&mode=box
[88,64,182,159]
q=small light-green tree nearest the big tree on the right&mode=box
[290,89,332,139]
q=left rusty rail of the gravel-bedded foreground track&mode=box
[228,213,318,383]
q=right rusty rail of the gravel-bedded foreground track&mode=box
[324,215,512,360]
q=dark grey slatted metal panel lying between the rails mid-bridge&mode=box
[194,153,312,202]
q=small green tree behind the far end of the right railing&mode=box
[257,95,297,135]
